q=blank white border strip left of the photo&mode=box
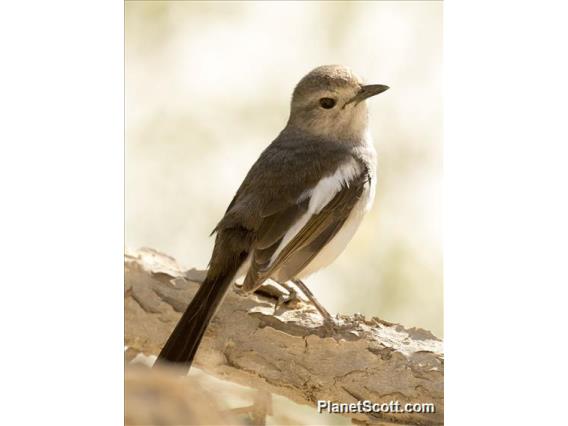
[0,1,124,426]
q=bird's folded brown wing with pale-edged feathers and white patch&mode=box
[243,161,369,291]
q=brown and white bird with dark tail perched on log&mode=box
[155,65,389,369]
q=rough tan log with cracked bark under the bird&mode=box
[124,249,444,425]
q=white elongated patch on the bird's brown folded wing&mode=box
[270,159,361,265]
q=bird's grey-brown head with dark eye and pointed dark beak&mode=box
[288,65,389,140]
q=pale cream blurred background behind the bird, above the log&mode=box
[125,1,443,422]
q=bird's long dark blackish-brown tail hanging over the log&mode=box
[156,251,242,368]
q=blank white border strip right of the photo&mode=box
[444,1,568,425]
